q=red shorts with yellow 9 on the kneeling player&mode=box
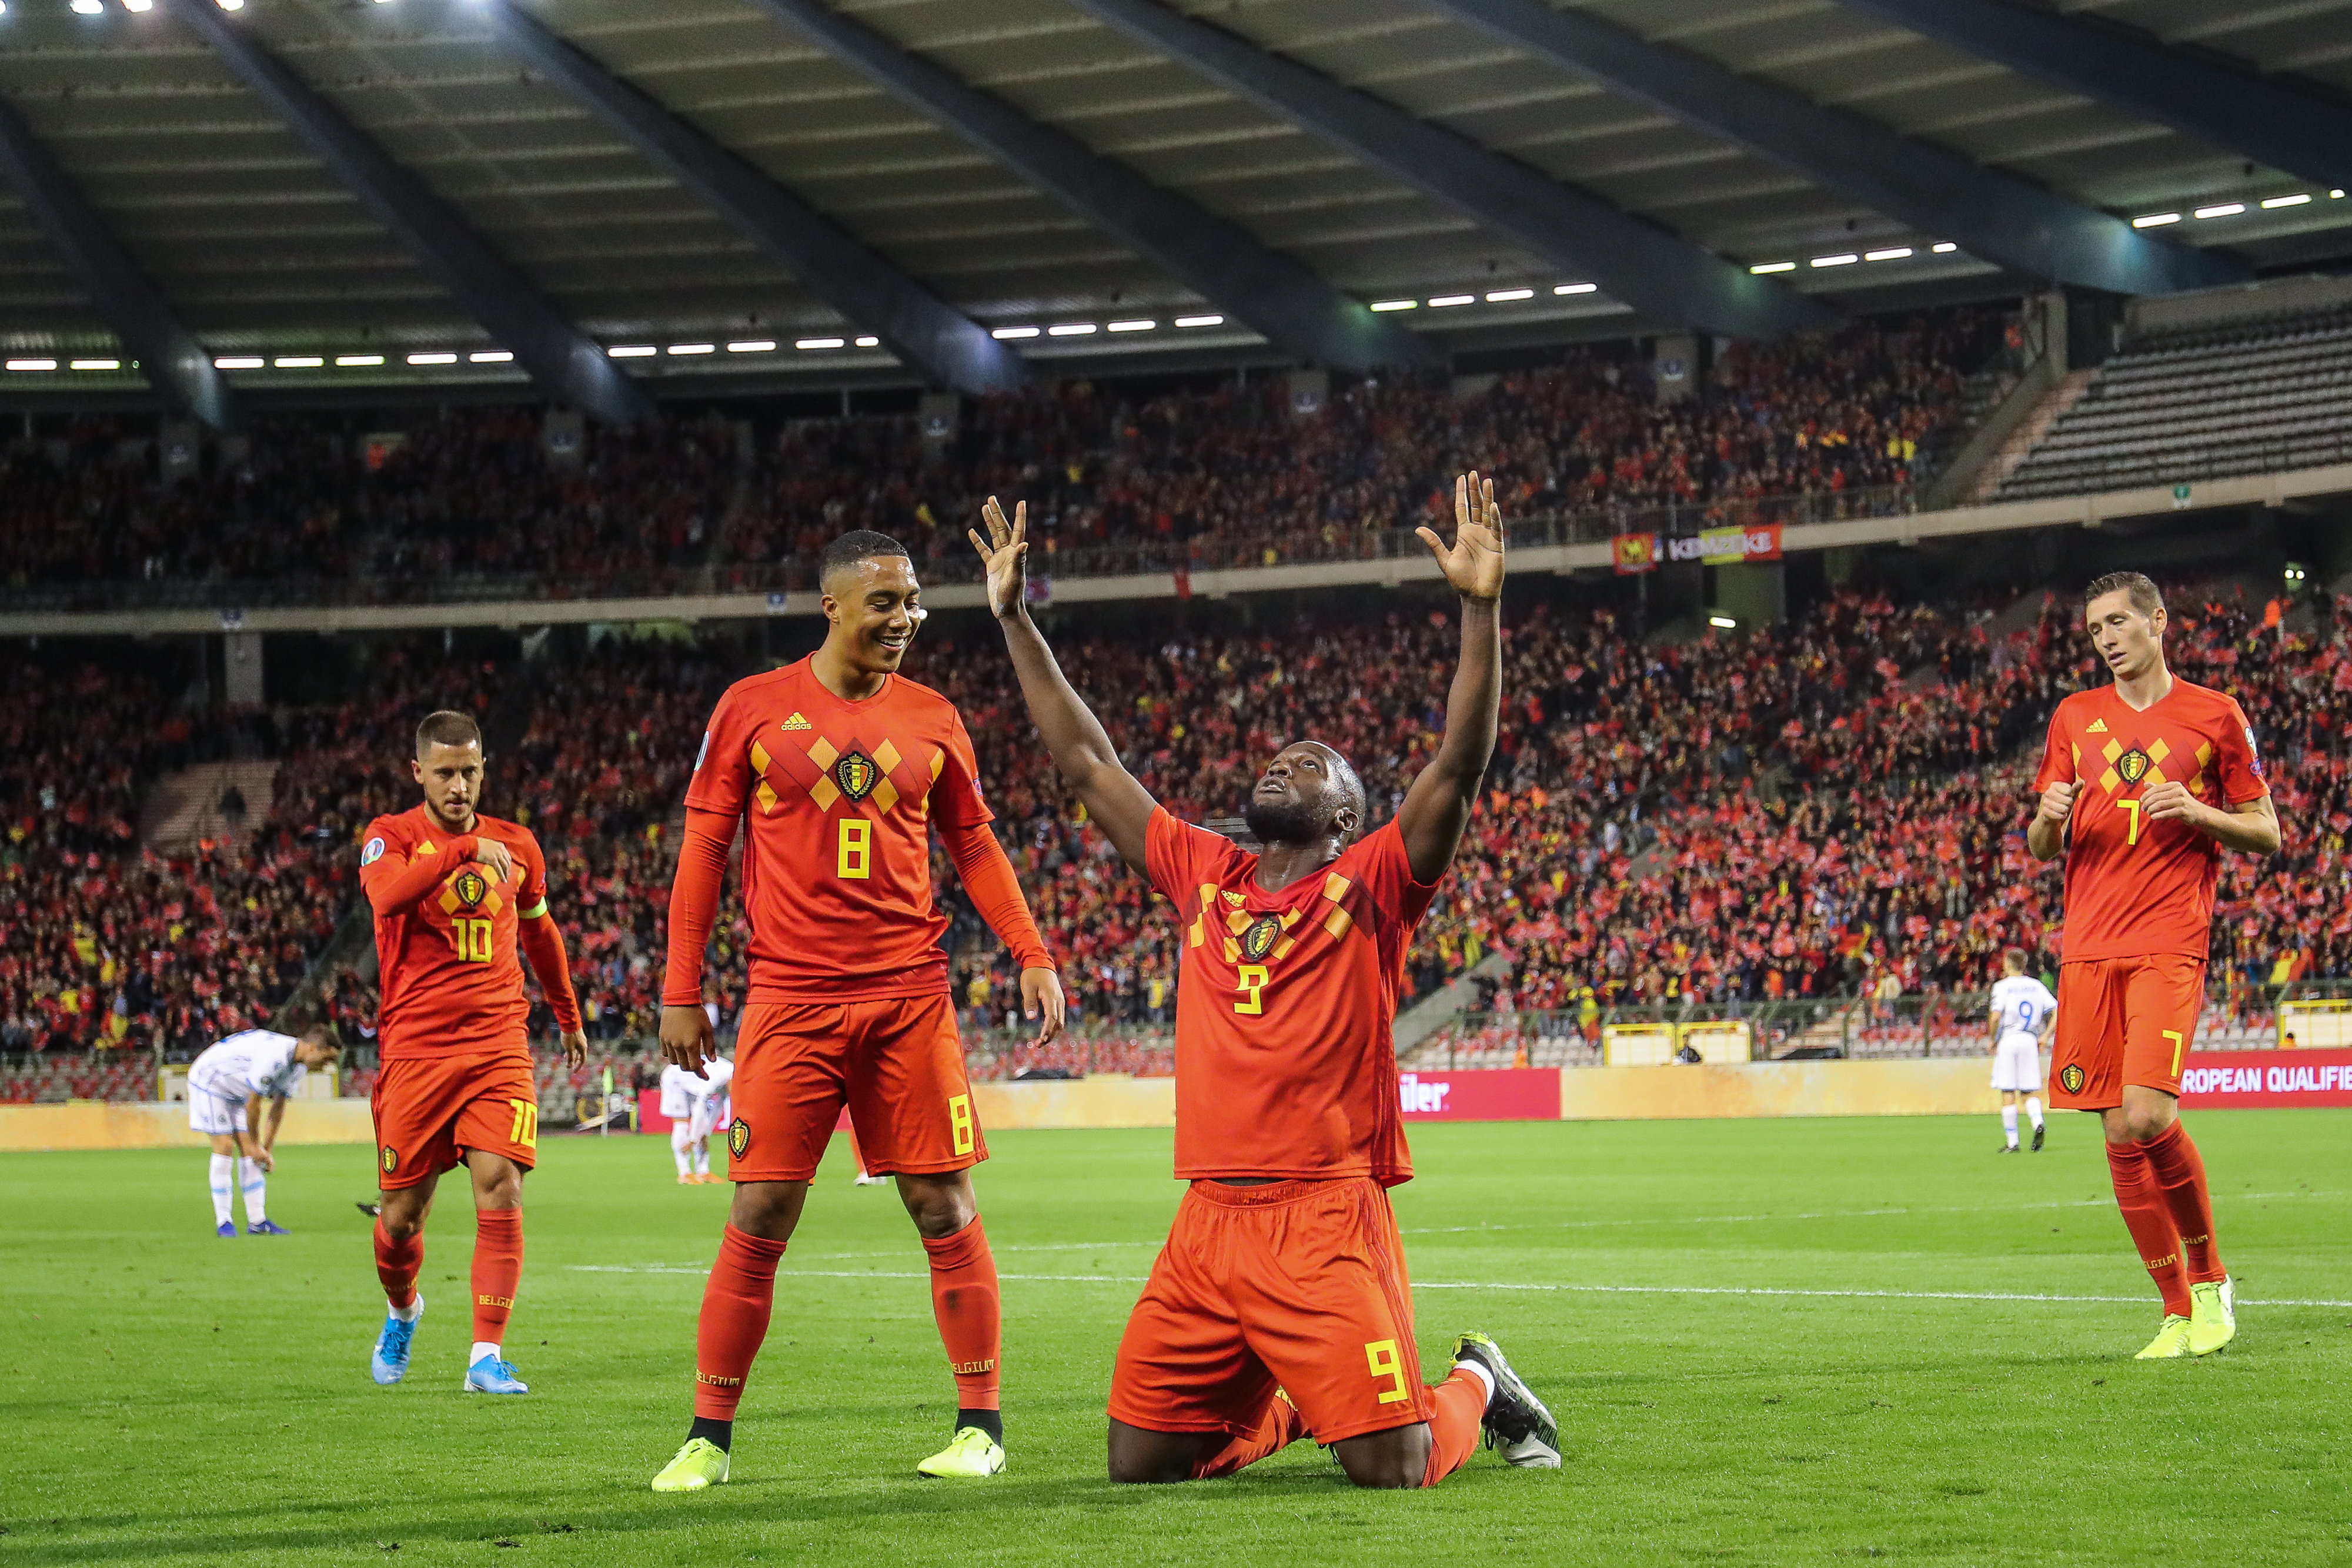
[1110,1178,1432,1443]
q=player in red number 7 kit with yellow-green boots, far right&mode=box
[2025,571,2279,1361]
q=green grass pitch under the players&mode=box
[0,1112,2352,1568]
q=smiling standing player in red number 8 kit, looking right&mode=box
[654,529,1063,1493]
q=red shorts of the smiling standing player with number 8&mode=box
[727,994,988,1182]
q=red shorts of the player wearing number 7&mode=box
[2051,952,2204,1109]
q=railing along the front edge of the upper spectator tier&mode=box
[0,484,1917,614]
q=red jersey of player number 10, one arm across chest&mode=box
[360,806,548,1062]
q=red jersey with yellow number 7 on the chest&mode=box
[2034,677,2270,959]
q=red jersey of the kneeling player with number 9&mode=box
[1145,808,1437,1187]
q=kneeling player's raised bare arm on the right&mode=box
[1397,473,1503,881]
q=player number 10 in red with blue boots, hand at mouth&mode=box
[360,713,588,1394]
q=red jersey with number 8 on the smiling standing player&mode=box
[687,658,995,1001]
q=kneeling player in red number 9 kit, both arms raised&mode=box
[971,475,1559,1486]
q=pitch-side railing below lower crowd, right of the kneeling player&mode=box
[1404,980,2352,1069]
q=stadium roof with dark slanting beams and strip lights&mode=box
[0,0,2352,419]
